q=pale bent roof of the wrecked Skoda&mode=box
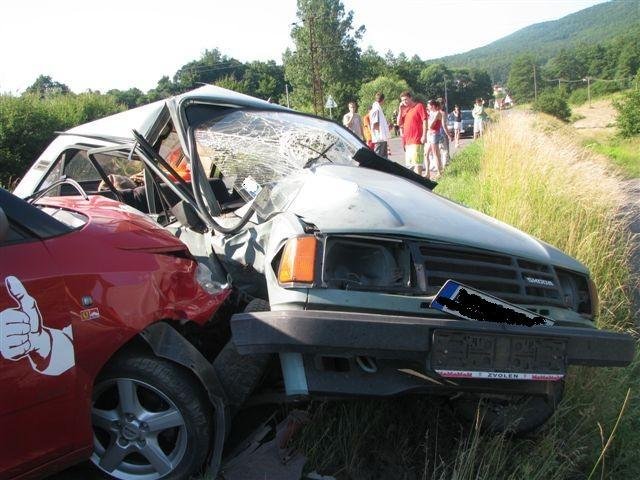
[66,85,288,140]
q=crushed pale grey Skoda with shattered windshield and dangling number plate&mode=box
[15,86,635,475]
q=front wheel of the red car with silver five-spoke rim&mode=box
[91,356,212,480]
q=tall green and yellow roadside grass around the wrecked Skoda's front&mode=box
[299,112,640,480]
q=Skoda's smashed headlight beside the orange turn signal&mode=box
[322,237,412,291]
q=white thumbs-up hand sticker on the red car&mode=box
[0,276,75,375]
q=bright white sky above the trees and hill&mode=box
[0,0,608,94]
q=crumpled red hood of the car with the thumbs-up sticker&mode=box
[37,195,187,252]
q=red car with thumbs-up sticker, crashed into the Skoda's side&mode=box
[0,187,229,479]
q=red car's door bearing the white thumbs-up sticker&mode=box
[0,193,79,478]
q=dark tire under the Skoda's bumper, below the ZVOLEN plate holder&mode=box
[452,382,564,436]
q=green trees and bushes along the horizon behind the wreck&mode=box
[0,0,640,186]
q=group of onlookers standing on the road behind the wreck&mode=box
[342,90,486,178]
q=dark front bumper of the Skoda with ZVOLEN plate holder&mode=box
[231,311,635,396]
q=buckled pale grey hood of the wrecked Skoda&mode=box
[287,165,586,272]
